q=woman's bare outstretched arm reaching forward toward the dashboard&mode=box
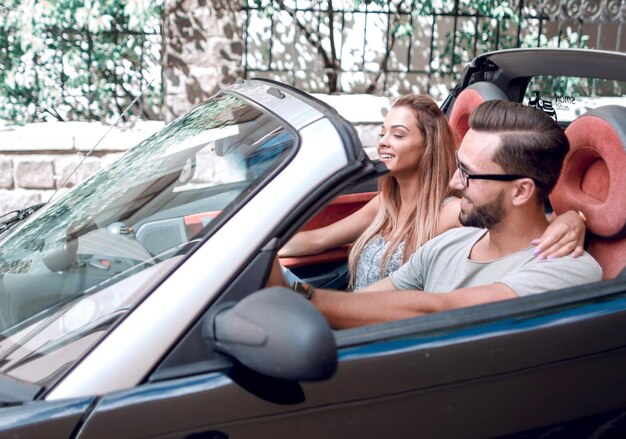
[278,196,380,258]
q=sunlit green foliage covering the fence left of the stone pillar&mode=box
[0,0,162,124]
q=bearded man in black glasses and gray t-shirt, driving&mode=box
[298,101,602,328]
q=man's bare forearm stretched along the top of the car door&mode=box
[311,278,517,329]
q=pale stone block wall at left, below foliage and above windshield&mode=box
[0,122,164,215]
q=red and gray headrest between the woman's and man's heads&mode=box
[448,81,507,148]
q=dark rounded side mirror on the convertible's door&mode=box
[203,287,337,381]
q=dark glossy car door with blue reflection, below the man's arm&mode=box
[73,246,626,438]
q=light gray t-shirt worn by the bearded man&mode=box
[389,227,602,296]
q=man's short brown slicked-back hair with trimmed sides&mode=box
[469,100,569,203]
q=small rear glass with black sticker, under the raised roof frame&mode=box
[524,76,626,125]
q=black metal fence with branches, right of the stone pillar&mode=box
[244,0,626,96]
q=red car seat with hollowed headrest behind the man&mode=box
[550,105,626,279]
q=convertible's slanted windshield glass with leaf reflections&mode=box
[0,93,296,385]
